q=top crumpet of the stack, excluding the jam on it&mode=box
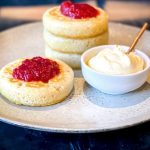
[43,6,108,39]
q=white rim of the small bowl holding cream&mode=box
[81,44,150,78]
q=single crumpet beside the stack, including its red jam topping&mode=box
[0,57,74,106]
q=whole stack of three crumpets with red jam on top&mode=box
[43,1,108,68]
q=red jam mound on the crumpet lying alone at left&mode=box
[12,57,60,83]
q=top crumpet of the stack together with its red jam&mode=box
[43,1,108,39]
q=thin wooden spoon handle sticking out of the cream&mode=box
[126,22,148,54]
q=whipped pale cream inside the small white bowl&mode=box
[88,46,144,75]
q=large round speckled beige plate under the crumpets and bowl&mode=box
[0,23,150,133]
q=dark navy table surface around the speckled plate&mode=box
[0,0,150,150]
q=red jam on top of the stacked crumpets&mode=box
[60,1,99,19]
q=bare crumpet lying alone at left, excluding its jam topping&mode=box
[0,59,74,106]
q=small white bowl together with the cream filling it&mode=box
[81,45,150,94]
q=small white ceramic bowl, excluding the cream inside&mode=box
[81,45,150,94]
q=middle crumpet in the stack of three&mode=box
[44,30,108,54]
